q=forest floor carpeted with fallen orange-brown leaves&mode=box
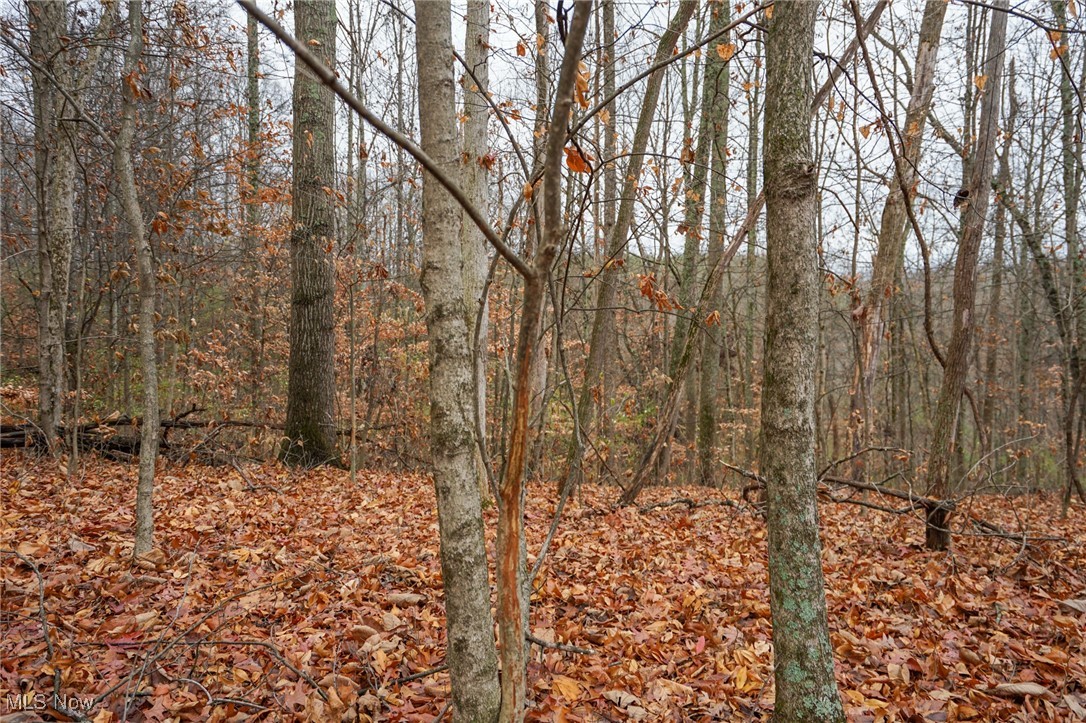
[0,451,1086,723]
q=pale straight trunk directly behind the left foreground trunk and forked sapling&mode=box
[460,0,491,496]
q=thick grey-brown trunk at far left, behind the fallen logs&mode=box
[27,0,78,454]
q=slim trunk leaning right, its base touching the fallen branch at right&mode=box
[925,0,1007,549]
